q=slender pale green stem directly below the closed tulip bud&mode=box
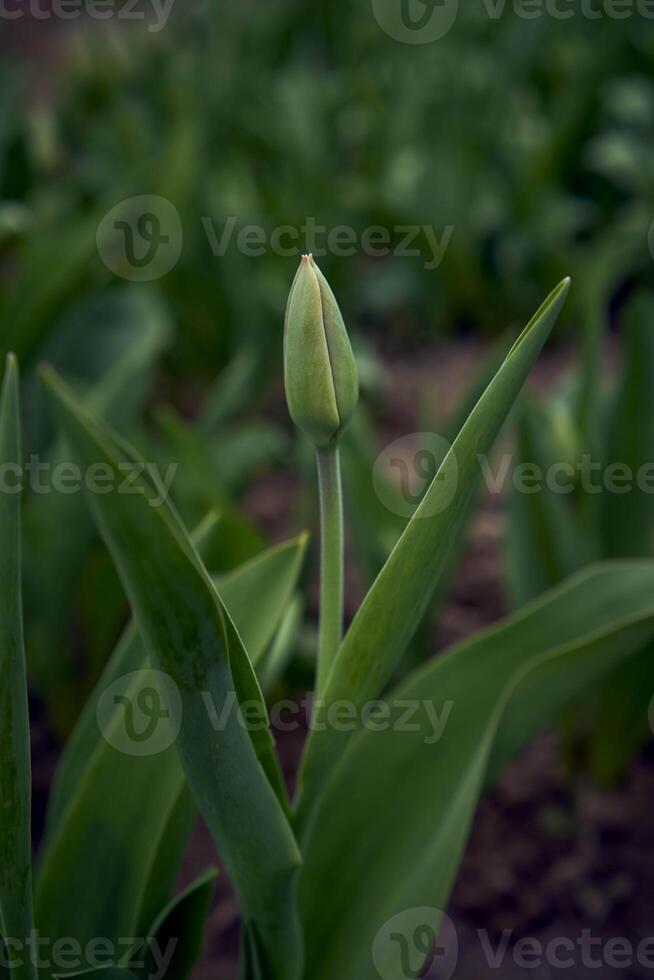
[316,443,343,697]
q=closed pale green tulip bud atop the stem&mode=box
[284,255,359,446]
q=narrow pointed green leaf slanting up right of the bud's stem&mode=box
[298,280,569,826]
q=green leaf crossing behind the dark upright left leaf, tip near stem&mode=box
[39,529,305,976]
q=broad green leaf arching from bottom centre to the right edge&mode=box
[300,562,654,980]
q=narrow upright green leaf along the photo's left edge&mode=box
[0,355,36,980]
